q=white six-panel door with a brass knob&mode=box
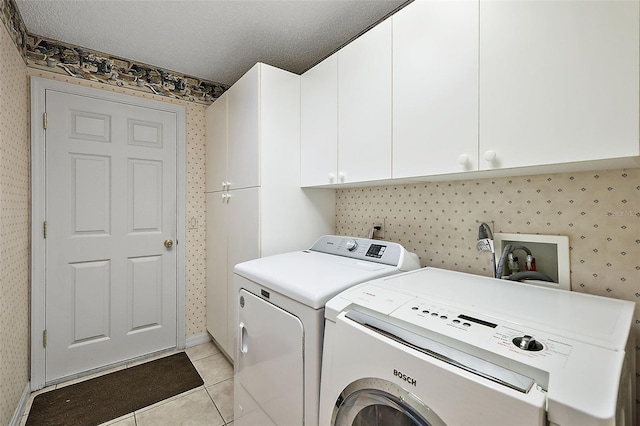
[45,90,177,383]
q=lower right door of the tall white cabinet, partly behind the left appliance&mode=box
[227,187,260,357]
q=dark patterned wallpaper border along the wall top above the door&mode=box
[0,0,229,105]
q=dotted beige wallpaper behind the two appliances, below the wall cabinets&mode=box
[336,169,640,404]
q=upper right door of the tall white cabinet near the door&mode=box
[226,64,260,189]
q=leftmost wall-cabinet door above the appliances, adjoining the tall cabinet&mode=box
[300,53,338,186]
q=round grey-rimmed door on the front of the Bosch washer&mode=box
[331,378,446,426]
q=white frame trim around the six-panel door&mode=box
[31,77,187,391]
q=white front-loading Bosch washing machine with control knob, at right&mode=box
[319,268,635,426]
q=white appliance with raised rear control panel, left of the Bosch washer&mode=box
[234,235,420,426]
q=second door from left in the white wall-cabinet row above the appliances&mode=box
[338,19,391,183]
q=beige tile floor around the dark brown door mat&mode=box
[21,342,233,426]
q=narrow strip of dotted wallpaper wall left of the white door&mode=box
[0,16,30,425]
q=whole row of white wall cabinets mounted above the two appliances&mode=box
[301,0,640,186]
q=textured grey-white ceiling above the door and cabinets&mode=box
[16,0,407,85]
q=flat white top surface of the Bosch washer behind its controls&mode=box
[372,268,634,351]
